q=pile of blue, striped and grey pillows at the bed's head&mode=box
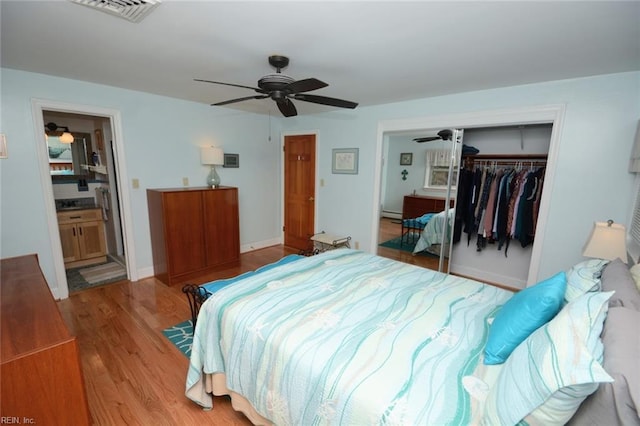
[484,259,640,425]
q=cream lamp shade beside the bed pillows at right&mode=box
[582,220,627,263]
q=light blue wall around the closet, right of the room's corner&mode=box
[286,72,640,277]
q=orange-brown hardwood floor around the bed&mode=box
[58,223,438,426]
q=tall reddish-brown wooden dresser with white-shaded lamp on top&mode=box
[147,187,240,285]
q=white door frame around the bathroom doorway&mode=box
[32,100,138,299]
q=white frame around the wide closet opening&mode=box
[369,104,565,286]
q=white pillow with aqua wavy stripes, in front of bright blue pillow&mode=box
[484,292,613,425]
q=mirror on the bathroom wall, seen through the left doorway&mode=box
[45,132,95,180]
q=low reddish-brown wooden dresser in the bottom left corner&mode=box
[0,254,90,425]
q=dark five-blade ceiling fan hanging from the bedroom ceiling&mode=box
[194,55,358,117]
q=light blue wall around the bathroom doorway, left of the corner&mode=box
[0,68,281,287]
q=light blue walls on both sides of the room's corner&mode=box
[0,69,640,292]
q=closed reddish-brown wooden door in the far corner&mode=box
[284,135,316,250]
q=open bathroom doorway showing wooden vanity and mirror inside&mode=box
[43,110,127,292]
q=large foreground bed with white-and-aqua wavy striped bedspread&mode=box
[186,249,636,425]
